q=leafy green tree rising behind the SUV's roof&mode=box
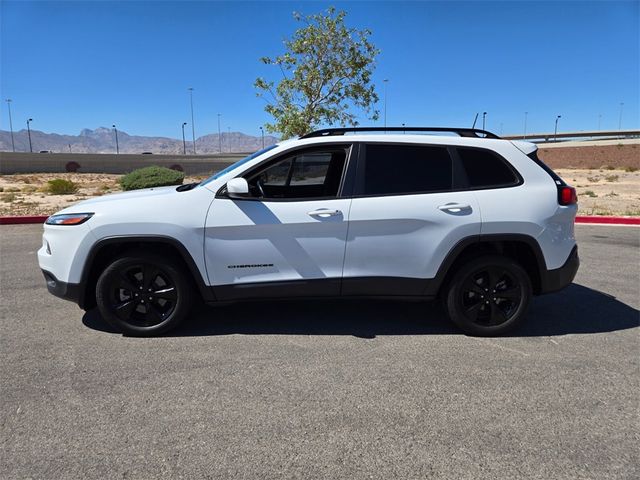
[255,7,379,138]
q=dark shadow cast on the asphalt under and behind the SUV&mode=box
[82,284,640,339]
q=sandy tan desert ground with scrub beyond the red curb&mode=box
[0,167,640,216]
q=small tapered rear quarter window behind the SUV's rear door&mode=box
[458,148,518,188]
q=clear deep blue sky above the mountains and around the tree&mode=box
[0,0,640,138]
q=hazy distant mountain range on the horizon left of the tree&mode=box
[0,127,278,154]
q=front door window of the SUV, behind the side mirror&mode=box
[247,147,348,199]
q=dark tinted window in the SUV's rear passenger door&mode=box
[361,144,453,195]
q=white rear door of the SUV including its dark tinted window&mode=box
[342,142,481,295]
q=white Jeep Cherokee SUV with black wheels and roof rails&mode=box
[38,127,579,335]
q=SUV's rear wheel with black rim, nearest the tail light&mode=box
[444,255,532,337]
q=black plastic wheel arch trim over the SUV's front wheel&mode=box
[78,235,215,310]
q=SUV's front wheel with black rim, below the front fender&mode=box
[96,252,193,336]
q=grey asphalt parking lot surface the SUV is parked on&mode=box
[0,225,640,479]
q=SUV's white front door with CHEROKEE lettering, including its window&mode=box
[205,145,351,300]
